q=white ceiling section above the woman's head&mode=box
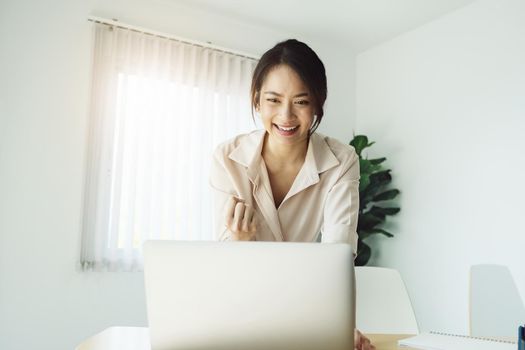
[172,0,476,52]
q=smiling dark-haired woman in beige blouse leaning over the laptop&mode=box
[210,39,374,349]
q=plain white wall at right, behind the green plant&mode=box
[357,0,525,332]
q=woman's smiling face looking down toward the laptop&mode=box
[258,65,314,145]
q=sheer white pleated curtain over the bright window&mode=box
[81,24,257,271]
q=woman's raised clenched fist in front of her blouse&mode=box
[224,197,256,241]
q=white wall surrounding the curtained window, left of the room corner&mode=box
[0,0,355,350]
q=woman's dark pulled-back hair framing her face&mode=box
[251,39,327,133]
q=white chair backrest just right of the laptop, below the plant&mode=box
[355,266,419,334]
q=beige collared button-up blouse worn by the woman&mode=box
[210,130,359,253]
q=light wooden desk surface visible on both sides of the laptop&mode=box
[75,327,416,350]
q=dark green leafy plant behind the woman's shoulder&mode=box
[350,135,400,266]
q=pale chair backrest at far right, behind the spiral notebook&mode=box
[469,264,525,337]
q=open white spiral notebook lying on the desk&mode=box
[399,332,518,350]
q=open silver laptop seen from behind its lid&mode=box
[144,241,355,350]
